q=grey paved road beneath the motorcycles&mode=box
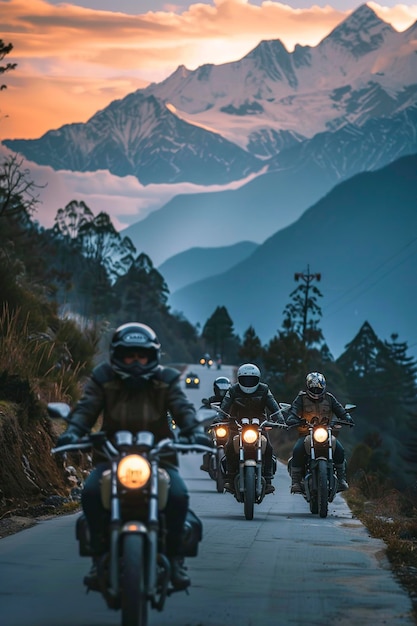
[0,364,415,626]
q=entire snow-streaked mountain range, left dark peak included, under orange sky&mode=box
[3,5,417,185]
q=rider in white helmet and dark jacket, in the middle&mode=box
[220,363,285,494]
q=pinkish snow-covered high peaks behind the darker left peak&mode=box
[145,5,417,151]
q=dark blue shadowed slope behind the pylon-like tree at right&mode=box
[169,155,417,357]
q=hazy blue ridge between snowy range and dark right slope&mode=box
[123,106,417,265]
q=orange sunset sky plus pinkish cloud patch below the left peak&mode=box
[0,0,417,228]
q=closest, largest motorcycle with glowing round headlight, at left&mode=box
[48,403,213,626]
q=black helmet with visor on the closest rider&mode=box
[110,322,161,378]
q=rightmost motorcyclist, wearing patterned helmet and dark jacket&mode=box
[287,372,354,493]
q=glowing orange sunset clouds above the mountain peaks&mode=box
[0,0,417,138]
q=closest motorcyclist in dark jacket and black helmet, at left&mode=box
[57,322,197,589]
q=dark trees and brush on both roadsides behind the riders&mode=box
[0,149,417,490]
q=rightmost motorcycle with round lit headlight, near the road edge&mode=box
[287,404,356,518]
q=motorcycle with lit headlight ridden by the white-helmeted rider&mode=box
[216,407,287,520]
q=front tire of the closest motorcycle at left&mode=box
[121,534,148,626]
